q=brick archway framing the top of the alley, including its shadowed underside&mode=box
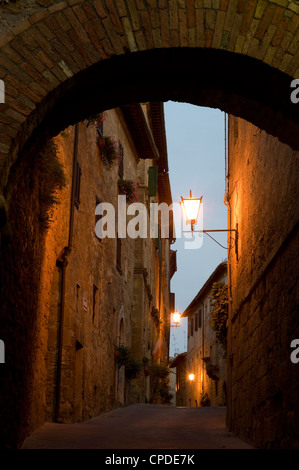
[0,0,299,195]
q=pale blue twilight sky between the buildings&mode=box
[164,101,227,356]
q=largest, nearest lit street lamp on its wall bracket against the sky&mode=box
[181,190,238,259]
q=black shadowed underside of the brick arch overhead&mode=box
[2,48,299,195]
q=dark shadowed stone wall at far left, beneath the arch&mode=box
[0,131,68,447]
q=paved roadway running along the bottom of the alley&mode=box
[22,404,251,449]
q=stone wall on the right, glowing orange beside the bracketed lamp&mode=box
[228,116,299,448]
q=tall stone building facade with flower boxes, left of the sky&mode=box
[40,103,176,422]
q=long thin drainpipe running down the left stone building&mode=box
[54,123,79,422]
